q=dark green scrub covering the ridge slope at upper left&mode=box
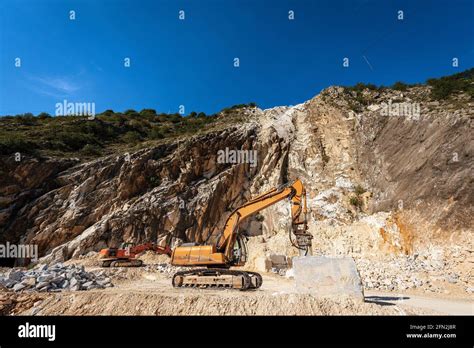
[0,103,256,158]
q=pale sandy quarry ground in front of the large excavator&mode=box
[11,268,474,315]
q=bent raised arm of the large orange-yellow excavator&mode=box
[216,180,311,260]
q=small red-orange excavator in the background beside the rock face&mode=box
[99,243,172,267]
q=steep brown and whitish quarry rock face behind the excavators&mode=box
[0,86,474,274]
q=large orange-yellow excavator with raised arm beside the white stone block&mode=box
[171,180,312,290]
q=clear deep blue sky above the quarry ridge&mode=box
[0,0,474,115]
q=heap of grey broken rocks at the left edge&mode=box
[0,263,113,292]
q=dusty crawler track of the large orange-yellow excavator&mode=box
[172,268,262,291]
